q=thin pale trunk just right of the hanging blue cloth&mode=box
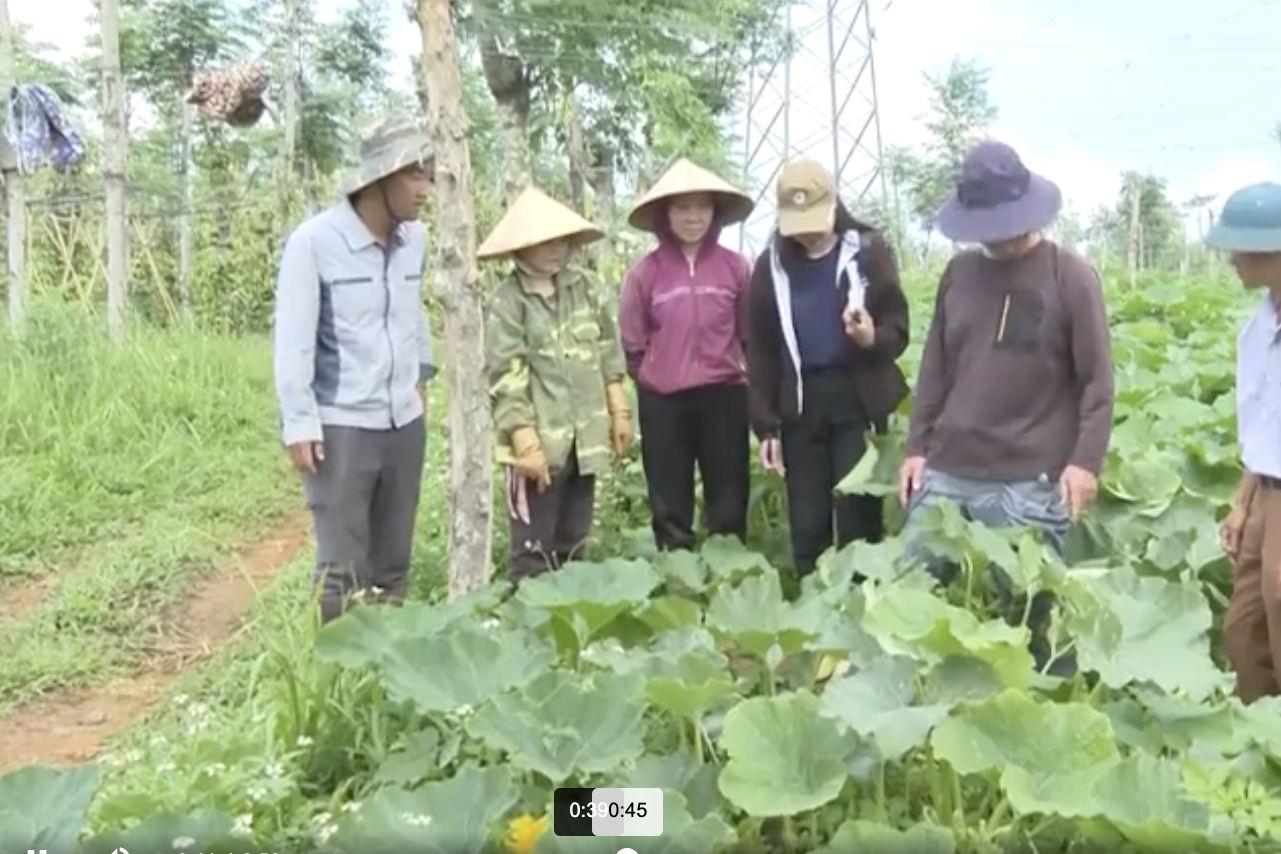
[99,0,129,338]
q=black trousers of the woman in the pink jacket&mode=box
[637,384,752,549]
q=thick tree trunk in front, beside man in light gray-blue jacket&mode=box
[418,0,493,597]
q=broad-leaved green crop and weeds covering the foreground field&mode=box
[0,272,1281,854]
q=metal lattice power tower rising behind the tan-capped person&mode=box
[739,0,885,256]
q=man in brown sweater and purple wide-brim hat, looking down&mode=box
[899,141,1113,675]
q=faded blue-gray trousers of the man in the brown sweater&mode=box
[903,469,1076,677]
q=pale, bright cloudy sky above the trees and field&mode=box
[9,0,1281,248]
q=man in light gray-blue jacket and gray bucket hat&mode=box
[273,118,436,621]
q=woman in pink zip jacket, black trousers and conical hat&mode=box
[619,160,753,549]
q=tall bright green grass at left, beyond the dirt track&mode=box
[0,303,283,574]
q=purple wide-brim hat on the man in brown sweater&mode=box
[934,140,1063,243]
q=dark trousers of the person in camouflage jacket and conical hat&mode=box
[507,449,596,584]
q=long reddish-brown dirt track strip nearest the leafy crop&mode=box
[0,513,309,772]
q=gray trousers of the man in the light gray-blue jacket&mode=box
[302,419,427,621]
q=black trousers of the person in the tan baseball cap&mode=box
[780,373,885,575]
